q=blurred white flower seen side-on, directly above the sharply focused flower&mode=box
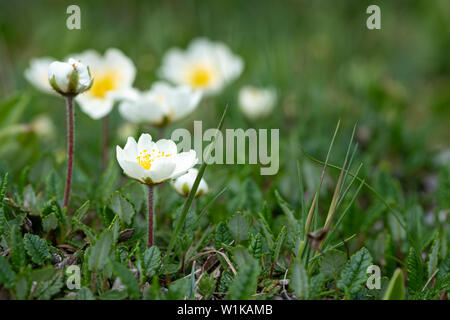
[119,82,201,125]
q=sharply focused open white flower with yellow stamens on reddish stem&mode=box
[116,134,198,184]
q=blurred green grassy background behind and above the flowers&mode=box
[0,0,450,208]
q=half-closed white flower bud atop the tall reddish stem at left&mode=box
[48,58,93,96]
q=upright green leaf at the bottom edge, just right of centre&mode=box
[228,261,260,300]
